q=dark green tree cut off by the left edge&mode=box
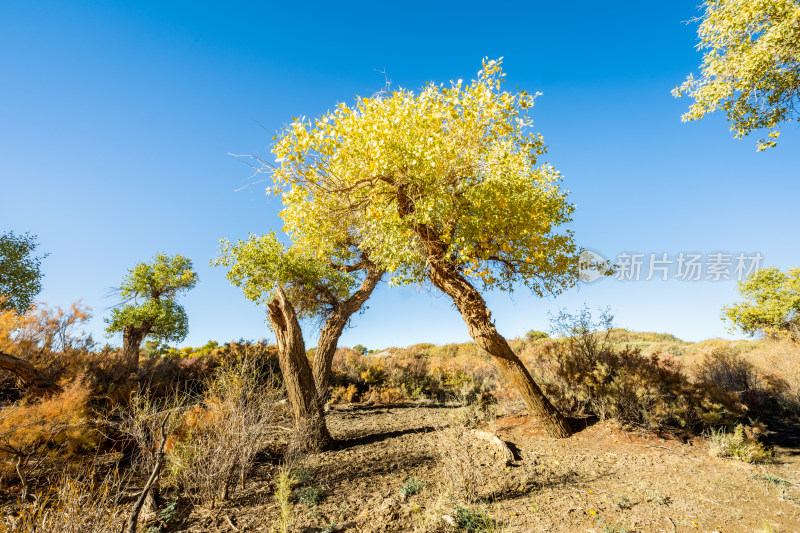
[0,231,48,314]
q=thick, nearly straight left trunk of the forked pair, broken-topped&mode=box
[267,287,333,452]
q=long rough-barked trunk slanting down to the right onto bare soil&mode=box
[414,220,572,438]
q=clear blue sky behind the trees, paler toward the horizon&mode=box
[0,0,800,348]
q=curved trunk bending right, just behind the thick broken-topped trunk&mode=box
[313,266,384,402]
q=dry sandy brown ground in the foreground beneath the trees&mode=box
[171,404,800,533]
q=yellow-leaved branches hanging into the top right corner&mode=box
[672,0,800,150]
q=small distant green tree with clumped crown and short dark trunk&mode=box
[105,254,197,371]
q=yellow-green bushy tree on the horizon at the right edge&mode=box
[722,267,800,342]
